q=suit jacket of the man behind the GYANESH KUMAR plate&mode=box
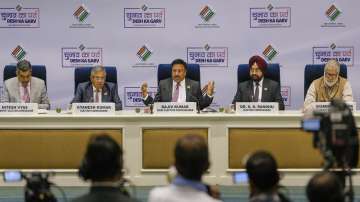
[71,81,122,110]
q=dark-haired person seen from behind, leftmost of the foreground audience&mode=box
[73,134,136,202]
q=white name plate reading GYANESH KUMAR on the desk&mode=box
[71,102,115,115]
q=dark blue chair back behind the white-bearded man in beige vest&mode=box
[304,64,347,99]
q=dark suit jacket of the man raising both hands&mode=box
[144,78,213,109]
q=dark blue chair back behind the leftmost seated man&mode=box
[3,65,47,86]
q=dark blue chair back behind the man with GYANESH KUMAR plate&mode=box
[74,66,117,93]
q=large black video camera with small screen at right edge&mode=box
[302,100,359,170]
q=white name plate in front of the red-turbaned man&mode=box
[236,102,279,114]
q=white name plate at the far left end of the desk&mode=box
[0,103,38,115]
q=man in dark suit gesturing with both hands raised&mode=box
[141,59,214,109]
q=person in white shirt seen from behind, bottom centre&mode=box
[149,135,219,202]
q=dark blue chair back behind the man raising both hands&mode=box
[158,64,200,83]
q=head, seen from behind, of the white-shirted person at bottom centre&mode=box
[175,135,210,181]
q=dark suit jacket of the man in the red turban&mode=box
[232,78,285,110]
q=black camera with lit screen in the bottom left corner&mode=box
[3,171,57,202]
